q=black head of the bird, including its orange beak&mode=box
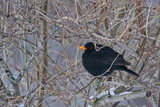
[80,42,96,53]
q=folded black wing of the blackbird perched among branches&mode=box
[91,46,130,65]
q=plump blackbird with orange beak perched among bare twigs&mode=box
[80,42,139,76]
